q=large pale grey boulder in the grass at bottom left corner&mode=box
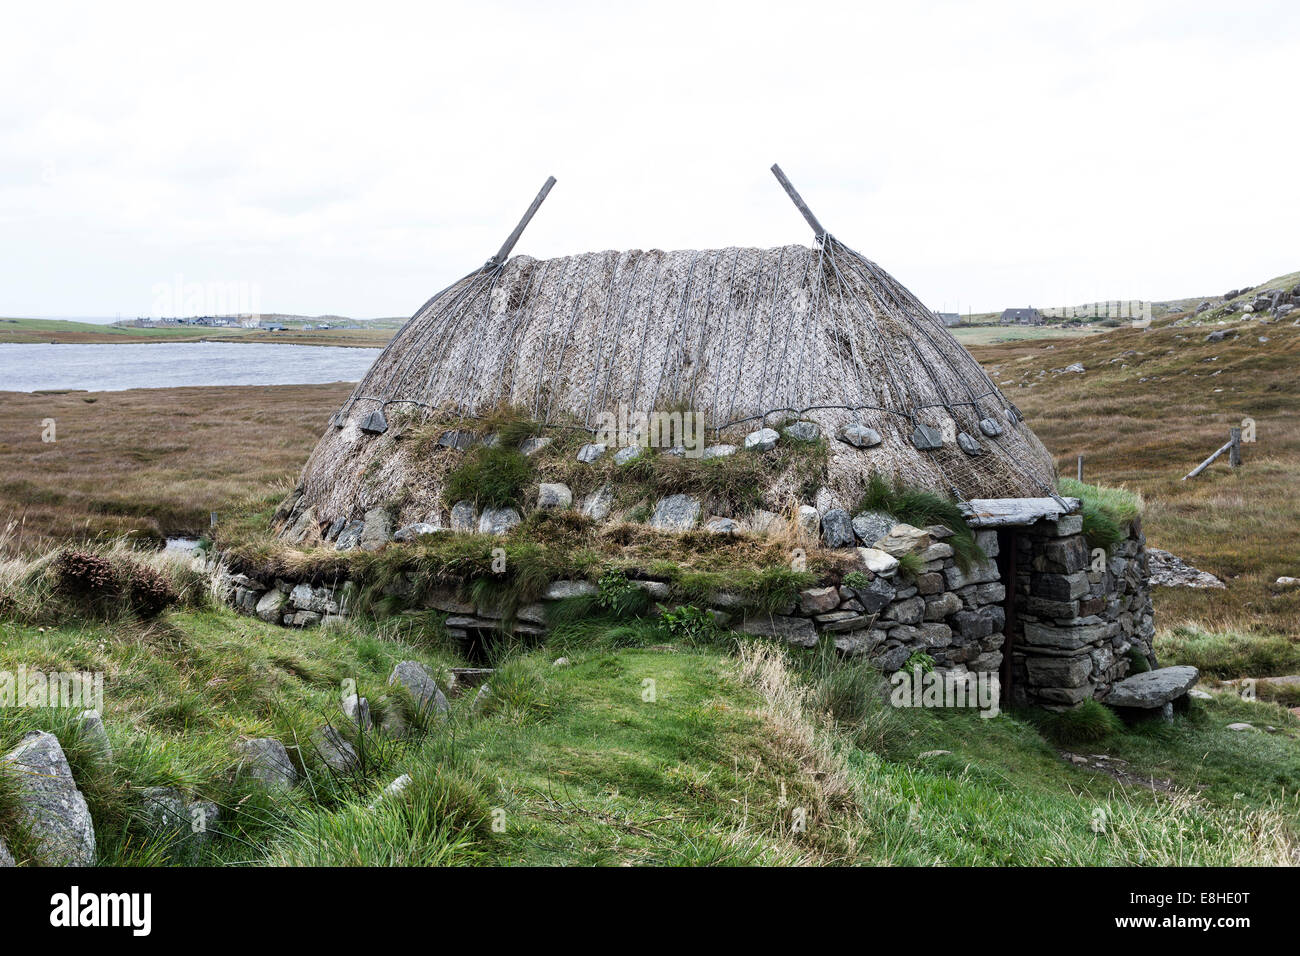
[0,731,95,866]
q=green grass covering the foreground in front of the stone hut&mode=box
[0,606,1300,865]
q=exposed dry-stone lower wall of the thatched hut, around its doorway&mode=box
[215,515,1154,709]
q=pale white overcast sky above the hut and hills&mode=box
[0,0,1300,316]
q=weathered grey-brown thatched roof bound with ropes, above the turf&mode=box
[289,171,1056,530]
